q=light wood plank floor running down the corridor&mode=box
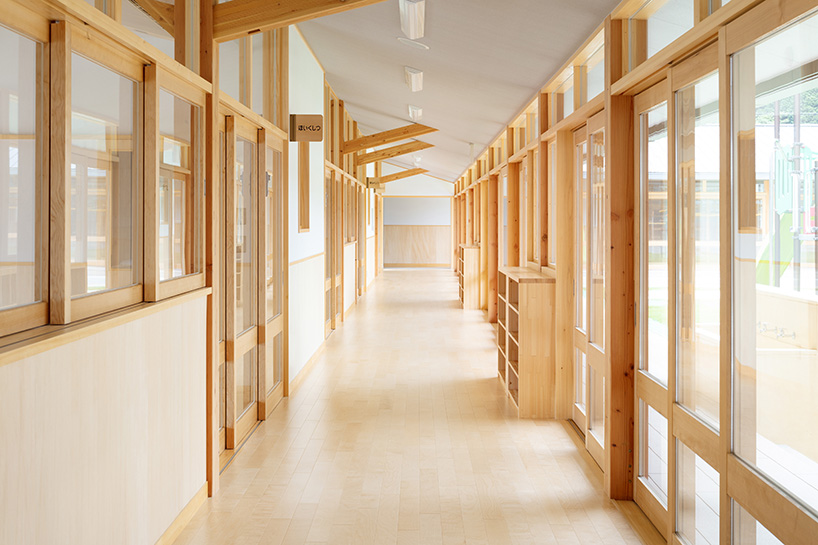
[177,270,664,545]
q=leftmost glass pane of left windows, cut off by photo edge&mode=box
[0,27,40,309]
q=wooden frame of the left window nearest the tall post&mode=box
[144,64,206,301]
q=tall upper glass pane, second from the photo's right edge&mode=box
[676,73,721,427]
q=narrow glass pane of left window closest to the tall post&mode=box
[159,89,199,281]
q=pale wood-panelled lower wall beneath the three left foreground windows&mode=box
[0,296,207,544]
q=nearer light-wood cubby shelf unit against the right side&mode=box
[490,267,556,418]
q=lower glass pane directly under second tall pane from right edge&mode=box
[676,440,719,545]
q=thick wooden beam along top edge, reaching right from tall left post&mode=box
[213,0,384,42]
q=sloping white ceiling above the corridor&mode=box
[298,0,619,181]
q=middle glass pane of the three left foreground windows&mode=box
[71,54,140,297]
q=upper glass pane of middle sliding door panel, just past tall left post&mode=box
[235,138,256,335]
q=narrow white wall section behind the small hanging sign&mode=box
[289,27,324,381]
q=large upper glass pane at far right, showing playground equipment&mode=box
[732,11,818,512]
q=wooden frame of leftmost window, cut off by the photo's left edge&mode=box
[0,11,49,337]
